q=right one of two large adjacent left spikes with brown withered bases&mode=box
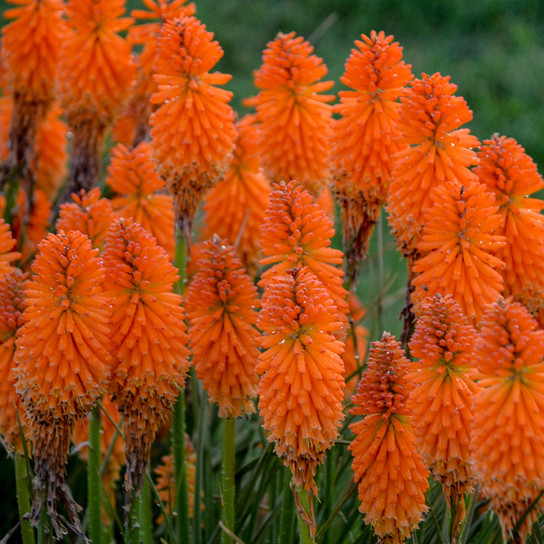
[103,219,189,512]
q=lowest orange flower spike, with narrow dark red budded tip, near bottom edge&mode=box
[349,333,429,544]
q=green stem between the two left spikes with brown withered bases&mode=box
[87,406,102,544]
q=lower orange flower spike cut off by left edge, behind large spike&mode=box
[0,268,28,454]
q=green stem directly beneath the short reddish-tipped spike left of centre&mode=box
[221,418,236,544]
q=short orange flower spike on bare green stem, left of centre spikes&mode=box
[186,236,259,418]
